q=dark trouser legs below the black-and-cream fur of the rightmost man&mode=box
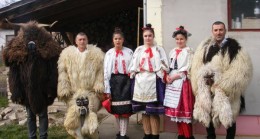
[206,122,236,139]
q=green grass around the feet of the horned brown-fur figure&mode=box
[0,124,73,139]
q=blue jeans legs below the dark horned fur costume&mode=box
[26,106,48,139]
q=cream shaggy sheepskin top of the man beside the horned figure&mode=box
[58,45,104,101]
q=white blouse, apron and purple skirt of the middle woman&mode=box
[130,46,168,114]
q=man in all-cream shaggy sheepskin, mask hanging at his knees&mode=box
[58,33,104,139]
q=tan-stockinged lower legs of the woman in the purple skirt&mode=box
[142,114,160,135]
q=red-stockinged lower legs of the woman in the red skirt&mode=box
[177,122,192,138]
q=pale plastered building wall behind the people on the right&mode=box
[147,0,260,115]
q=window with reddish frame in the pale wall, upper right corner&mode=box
[228,0,260,31]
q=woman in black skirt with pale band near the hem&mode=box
[104,28,133,139]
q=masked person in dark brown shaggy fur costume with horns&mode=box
[3,21,61,139]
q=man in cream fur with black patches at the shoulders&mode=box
[191,21,253,139]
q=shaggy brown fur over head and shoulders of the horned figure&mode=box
[3,21,62,66]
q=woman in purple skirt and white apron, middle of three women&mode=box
[130,24,168,139]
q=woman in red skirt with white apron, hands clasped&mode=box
[164,26,194,139]
